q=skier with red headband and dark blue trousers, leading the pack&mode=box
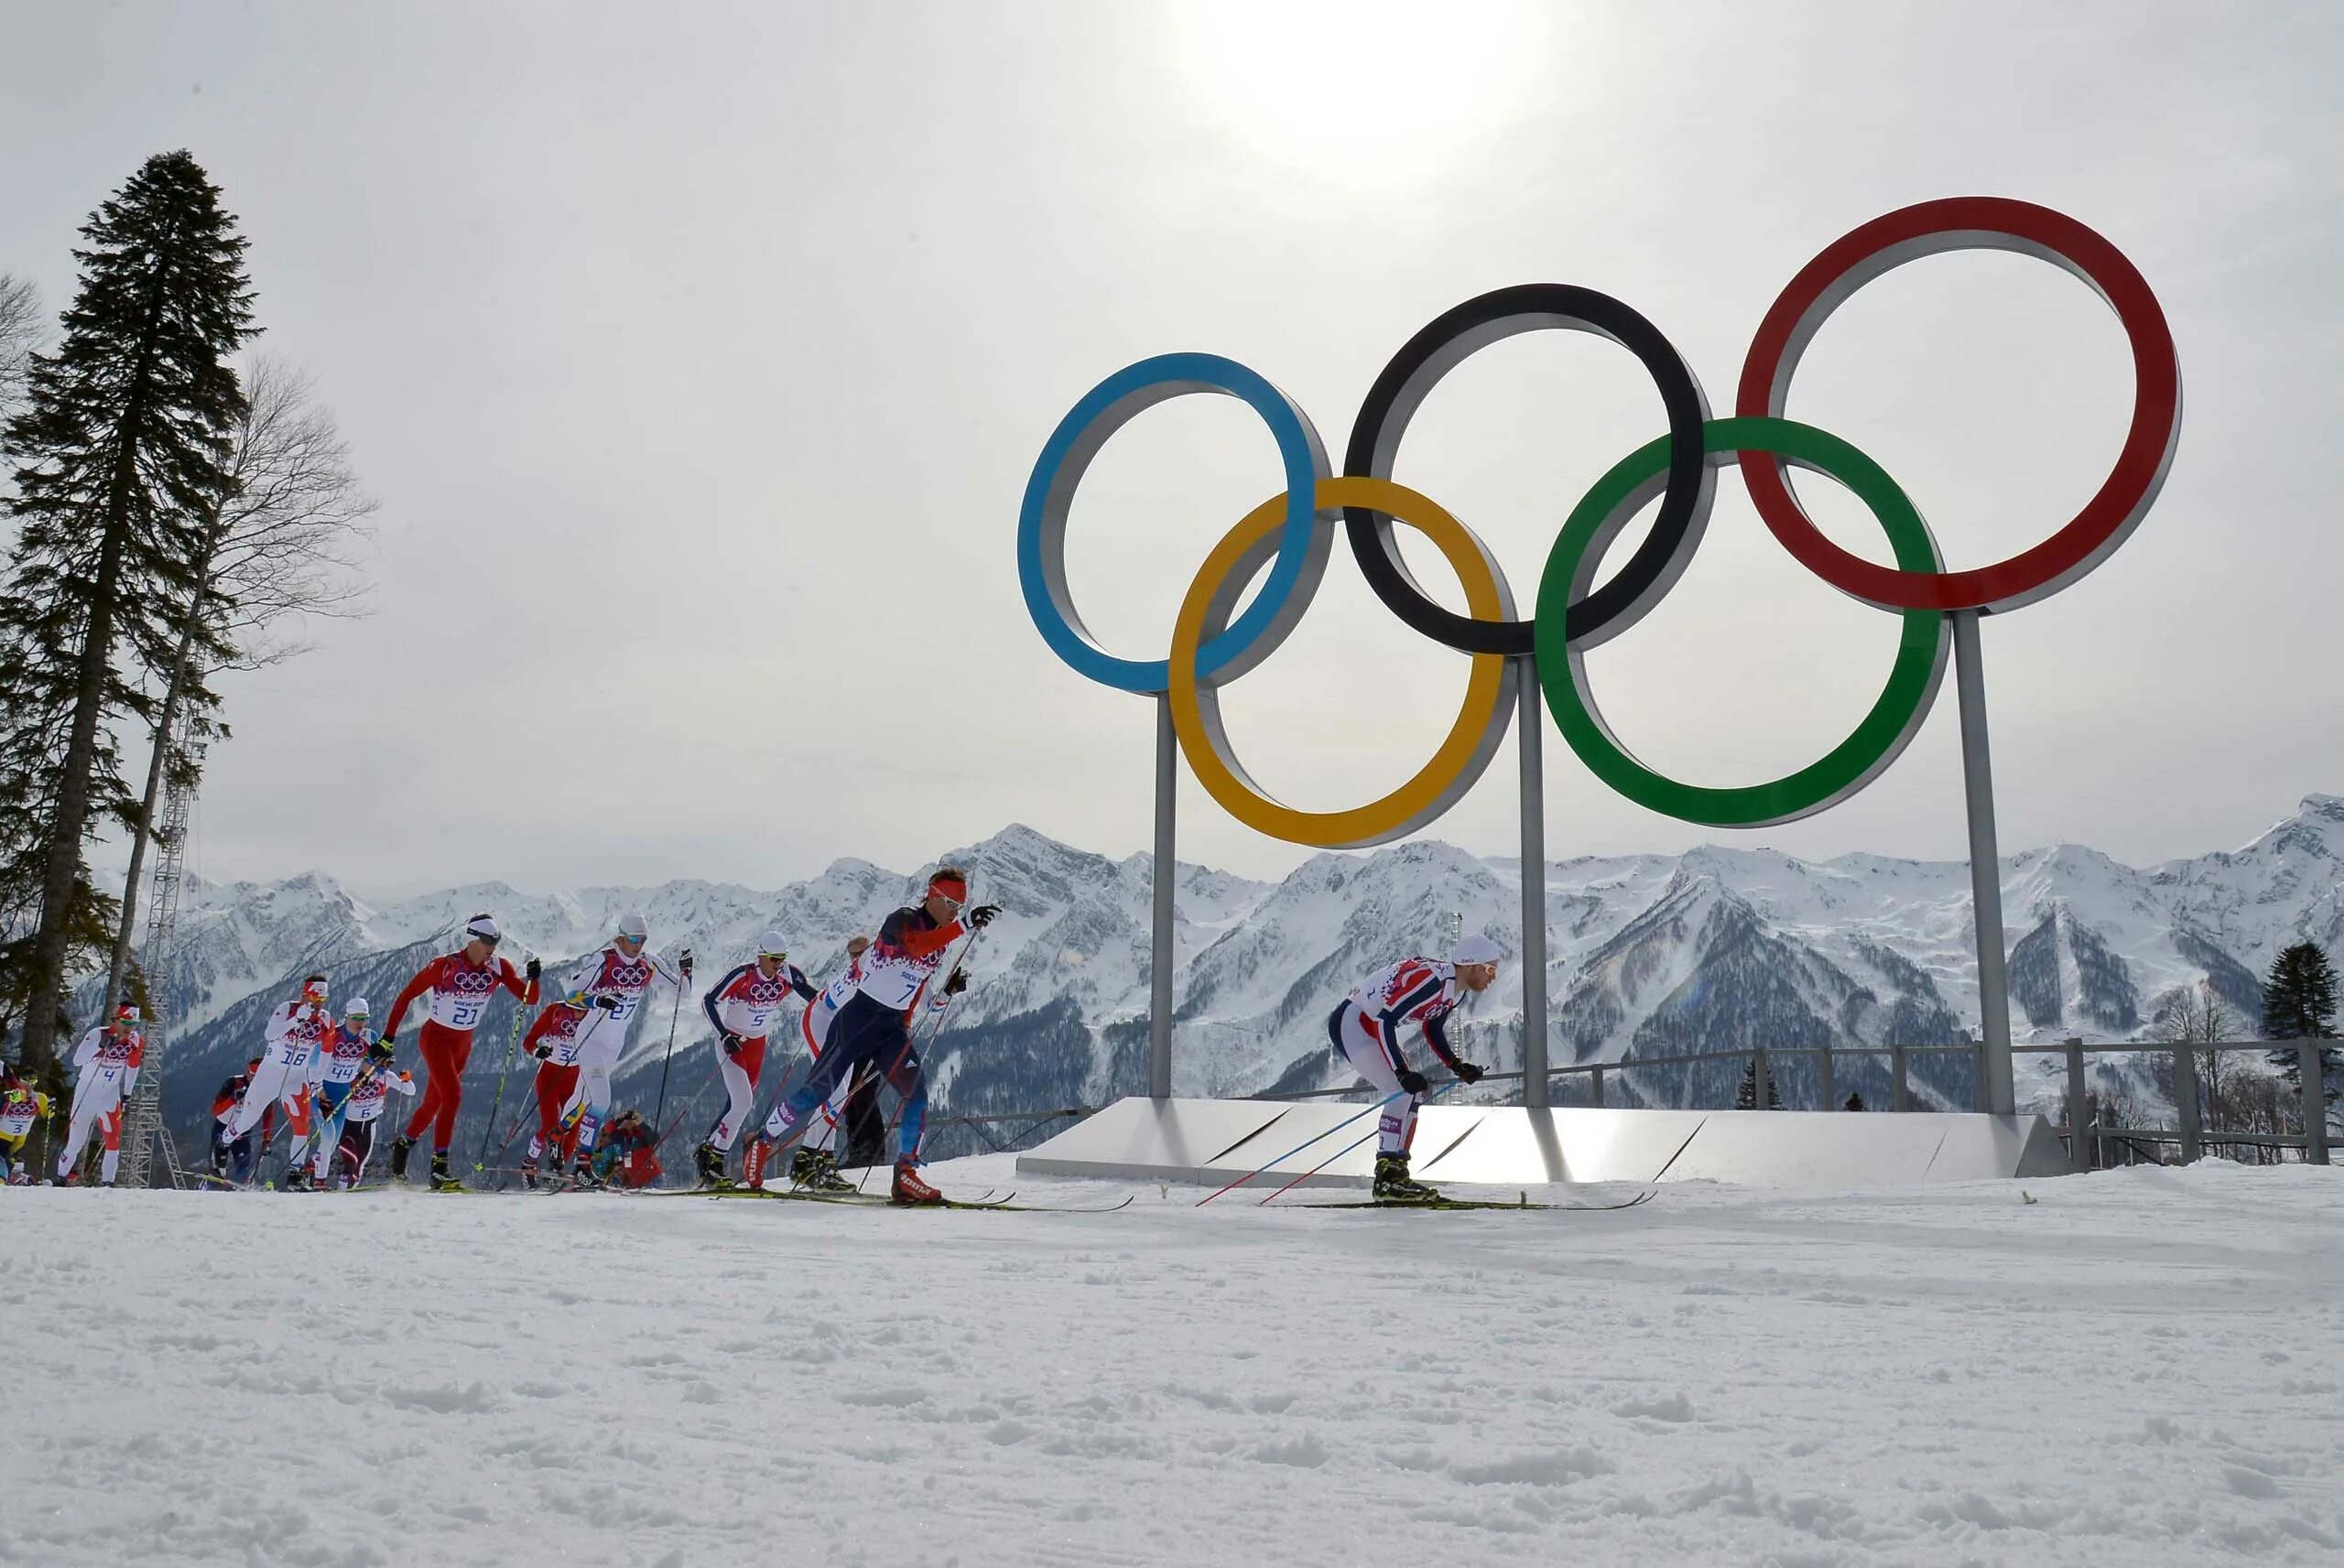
[748,865,1001,1203]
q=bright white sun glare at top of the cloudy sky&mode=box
[1172,0,1540,185]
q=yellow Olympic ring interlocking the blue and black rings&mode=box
[1169,476,1514,849]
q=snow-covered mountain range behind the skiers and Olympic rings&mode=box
[114,795,2344,1162]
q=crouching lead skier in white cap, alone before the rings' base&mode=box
[1327,931,1498,1203]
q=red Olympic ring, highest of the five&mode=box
[1734,197,2182,611]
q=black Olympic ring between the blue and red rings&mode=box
[1343,284,1718,659]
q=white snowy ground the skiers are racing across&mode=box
[0,1158,2344,1568]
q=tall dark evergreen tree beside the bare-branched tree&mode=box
[0,152,253,1071]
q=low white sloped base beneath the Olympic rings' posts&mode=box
[1017,1095,2065,1188]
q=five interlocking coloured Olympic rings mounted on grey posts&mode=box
[1017,197,2182,849]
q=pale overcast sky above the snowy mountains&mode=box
[0,0,2344,893]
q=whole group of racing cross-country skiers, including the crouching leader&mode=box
[0,865,1500,1205]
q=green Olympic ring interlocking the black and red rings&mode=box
[1536,415,1950,827]
